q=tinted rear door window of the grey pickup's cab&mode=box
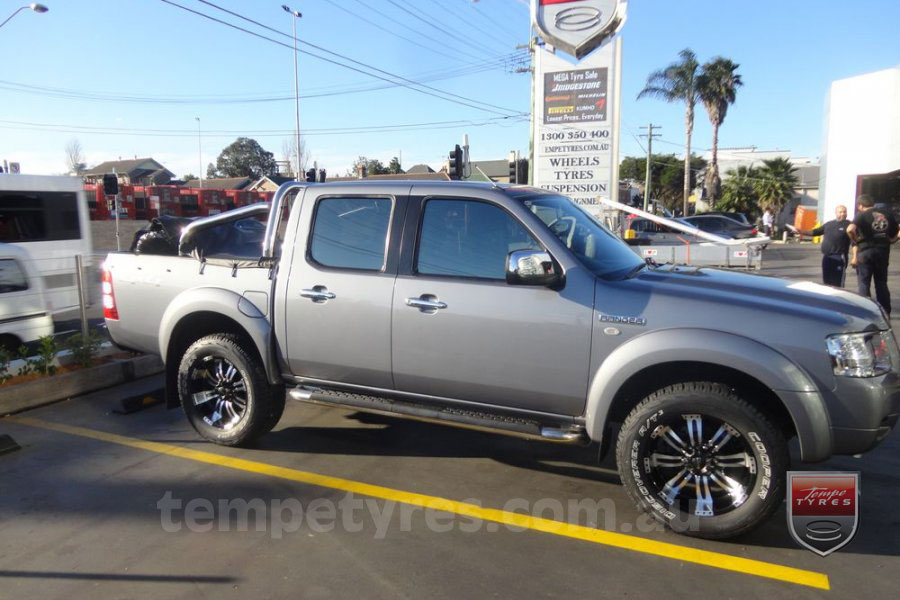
[309,198,393,271]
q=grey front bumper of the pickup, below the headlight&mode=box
[824,372,900,454]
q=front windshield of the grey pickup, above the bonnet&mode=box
[518,194,645,279]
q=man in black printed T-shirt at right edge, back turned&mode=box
[847,194,900,316]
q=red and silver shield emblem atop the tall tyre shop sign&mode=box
[531,0,628,60]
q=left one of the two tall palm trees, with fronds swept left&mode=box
[638,48,700,216]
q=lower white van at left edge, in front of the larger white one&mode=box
[0,243,53,353]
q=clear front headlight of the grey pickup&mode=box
[825,331,896,377]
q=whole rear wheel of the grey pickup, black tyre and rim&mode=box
[178,334,284,446]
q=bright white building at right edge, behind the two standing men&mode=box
[819,66,900,220]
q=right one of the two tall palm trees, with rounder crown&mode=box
[697,56,744,206]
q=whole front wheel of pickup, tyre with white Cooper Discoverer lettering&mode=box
[616,382,790,539]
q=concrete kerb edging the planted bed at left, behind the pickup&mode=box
[0,355,163,415]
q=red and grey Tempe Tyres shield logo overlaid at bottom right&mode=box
[787,471,859,556]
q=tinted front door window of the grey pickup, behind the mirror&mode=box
[416,199,542,280]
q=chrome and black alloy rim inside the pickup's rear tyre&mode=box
[188,355,247,431]
